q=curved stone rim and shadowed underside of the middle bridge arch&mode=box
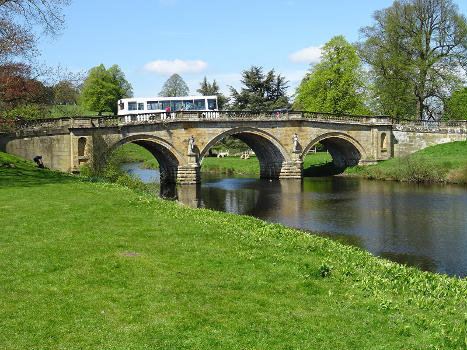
[199,127,291,179]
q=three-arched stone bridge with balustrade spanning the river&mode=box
[0,111,467,184]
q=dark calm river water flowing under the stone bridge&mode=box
[124,163,467,277]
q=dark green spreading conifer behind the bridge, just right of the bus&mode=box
[230,66,290,111]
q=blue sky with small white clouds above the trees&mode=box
[39,0,467,97]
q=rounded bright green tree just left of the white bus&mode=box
[80,64,133,115]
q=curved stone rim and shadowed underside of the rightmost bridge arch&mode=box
[302,132,367,168]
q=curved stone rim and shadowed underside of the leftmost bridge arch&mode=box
[110,135,184,182]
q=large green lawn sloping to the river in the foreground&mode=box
[0,153,467,349]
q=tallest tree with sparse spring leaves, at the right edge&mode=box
[359,0,467,119]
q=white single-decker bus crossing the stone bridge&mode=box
[118,96,217,115]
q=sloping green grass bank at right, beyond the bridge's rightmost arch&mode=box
[344,141,467,184]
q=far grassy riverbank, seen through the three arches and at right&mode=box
[111,141,467,184]
